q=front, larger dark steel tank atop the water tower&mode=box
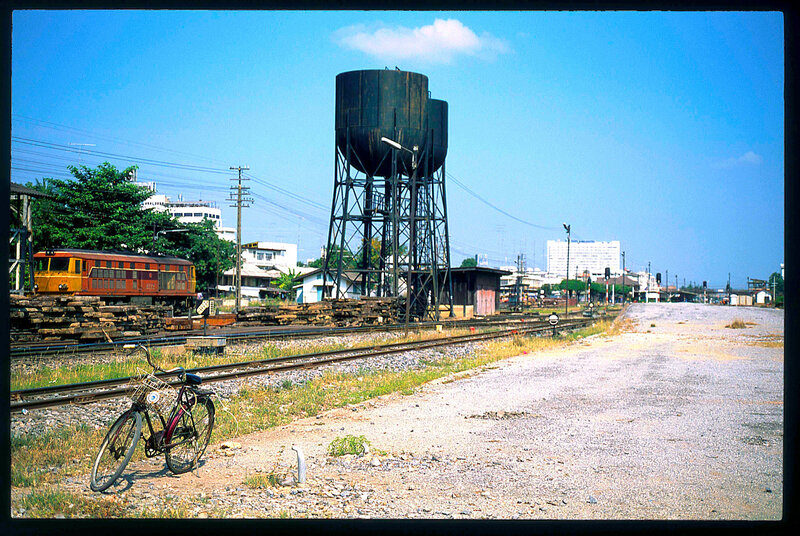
[336,69,428,177]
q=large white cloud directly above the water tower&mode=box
[334,19,510,63]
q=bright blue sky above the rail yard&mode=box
[11,10,784,288]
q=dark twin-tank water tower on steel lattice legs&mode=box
[323,69,452,319]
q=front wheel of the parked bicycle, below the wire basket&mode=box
[89,410,142,491]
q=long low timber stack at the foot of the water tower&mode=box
[236,298,399,327]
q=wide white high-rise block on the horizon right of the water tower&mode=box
[547,240,621,278]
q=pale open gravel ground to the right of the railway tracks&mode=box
[12,304,784,520]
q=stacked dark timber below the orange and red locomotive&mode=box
[9,294,170,342]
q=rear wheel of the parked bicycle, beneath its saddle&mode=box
[164,397,215,474]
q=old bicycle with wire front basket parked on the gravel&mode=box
[89,344,215,491]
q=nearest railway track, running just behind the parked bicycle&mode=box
[10,318,608,412]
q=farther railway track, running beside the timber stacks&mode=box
[10,314,600,361]
